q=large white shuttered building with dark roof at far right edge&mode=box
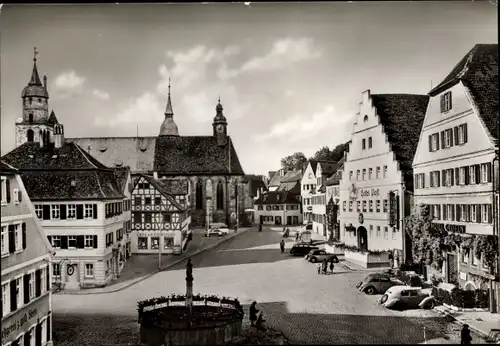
[413,44,499,310]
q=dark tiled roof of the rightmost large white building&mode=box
[429,44,499,139]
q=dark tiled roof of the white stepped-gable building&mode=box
[371,94,429,190]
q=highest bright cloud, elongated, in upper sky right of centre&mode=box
[240,38,321,72]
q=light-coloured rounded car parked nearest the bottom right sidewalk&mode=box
[379,285,436,309]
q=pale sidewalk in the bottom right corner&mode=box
[434,305,500,343]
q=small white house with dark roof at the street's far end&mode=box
[255,191,302,226]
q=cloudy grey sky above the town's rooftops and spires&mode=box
[0,1,498,174]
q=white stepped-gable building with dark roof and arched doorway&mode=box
[340,90,429,265]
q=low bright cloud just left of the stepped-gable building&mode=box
[254,105,352,143]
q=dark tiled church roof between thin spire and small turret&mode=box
[154,136,245,175]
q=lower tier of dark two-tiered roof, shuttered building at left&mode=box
[21,170,125,200]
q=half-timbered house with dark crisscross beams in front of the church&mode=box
[131,175,191,254]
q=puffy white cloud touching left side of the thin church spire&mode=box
[94,92,164,130]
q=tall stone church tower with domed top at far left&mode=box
[16,47,58,147]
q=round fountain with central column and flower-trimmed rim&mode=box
[138,259,244,346]
